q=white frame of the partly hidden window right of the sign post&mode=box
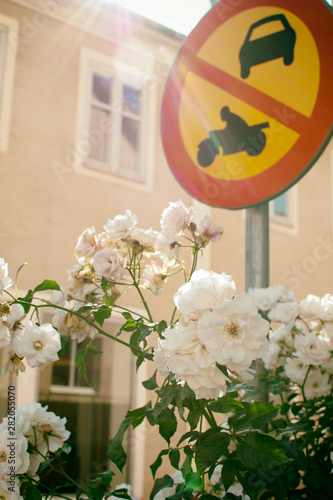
[269,184,298,234]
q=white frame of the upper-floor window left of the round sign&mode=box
[73,48,157,191]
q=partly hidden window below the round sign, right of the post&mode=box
[270,185,297,232]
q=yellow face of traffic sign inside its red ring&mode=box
[179,7,320,181]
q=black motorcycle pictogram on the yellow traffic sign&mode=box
[197,106,269,167]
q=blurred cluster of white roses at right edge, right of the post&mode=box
[249,286,333,398]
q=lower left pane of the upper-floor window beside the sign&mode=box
[89,106,111,163]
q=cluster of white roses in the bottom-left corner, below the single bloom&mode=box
[0,403,70,500]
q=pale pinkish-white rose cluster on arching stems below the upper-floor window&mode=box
[52,201,223,342]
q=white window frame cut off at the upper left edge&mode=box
[0,14,19,152]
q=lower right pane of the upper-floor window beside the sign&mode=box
[120,117,140,172]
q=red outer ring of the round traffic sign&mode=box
[161,0,333,209]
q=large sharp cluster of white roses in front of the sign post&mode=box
[154,270,269,399]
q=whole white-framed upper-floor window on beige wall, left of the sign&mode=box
[75,49,157,189]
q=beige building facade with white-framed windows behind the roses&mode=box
[0,0,333,499]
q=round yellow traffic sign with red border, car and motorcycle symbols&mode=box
[161,0,333,208]
